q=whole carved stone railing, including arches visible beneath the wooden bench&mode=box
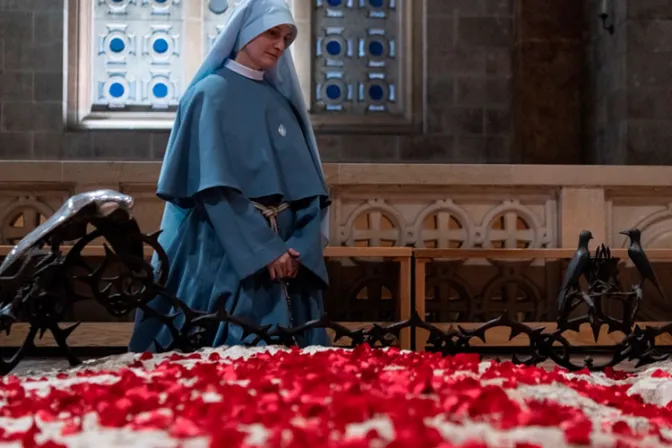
[0,161,672,354]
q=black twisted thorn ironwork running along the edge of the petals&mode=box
[0,192,672,374]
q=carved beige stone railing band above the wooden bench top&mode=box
[0,161,672,249]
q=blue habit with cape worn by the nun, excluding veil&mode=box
[129,67,329,352]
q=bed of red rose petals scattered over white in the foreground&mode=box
[0,346,672,448]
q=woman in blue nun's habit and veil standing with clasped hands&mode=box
[129,0,330,352]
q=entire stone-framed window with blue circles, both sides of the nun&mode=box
[67,0,414,131]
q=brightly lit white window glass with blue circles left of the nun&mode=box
[91,0,232,110]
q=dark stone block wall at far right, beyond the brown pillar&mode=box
[585,0,672,165]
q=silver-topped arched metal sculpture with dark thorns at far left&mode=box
[0,190,163,374]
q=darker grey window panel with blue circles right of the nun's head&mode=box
[313,0,403,114]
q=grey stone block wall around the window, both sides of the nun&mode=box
[0,0,513,163]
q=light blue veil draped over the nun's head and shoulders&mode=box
[157,0,329,246]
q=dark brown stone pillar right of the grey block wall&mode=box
[512,0,583,164]
